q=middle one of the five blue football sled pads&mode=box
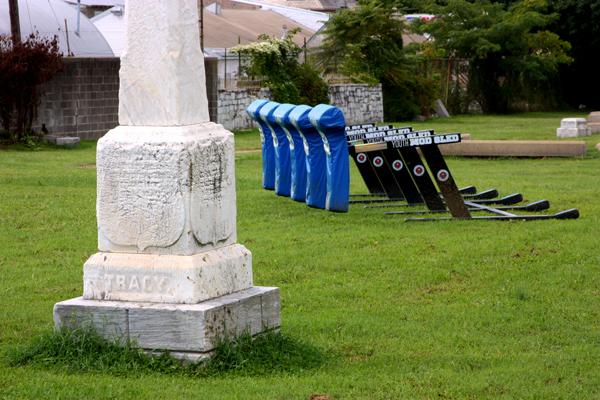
[273,104,306,202]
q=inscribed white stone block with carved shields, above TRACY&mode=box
[97,123,236,255]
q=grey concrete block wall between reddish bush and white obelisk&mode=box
[34,57,120,139]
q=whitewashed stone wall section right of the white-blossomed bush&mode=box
[329,84,383,125]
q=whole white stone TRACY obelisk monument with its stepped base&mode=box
[54,0,281,361]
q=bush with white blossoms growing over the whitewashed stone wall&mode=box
[231,29,329,106]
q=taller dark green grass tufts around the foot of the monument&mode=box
[6,323,334,377]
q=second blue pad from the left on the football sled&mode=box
[259,101,292,197]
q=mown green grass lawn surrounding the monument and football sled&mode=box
[0,113,600,400]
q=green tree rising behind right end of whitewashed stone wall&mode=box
[314,1,436,121]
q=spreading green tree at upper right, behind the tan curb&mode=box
[414,0,572,113]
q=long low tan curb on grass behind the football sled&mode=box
[440,140,587,157]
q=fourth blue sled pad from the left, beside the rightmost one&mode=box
[289,105,327,209]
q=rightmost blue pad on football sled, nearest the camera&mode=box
[308,104,350,212]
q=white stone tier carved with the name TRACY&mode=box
[83,244,252,304]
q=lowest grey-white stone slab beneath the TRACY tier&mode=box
[54,286,281,361]
